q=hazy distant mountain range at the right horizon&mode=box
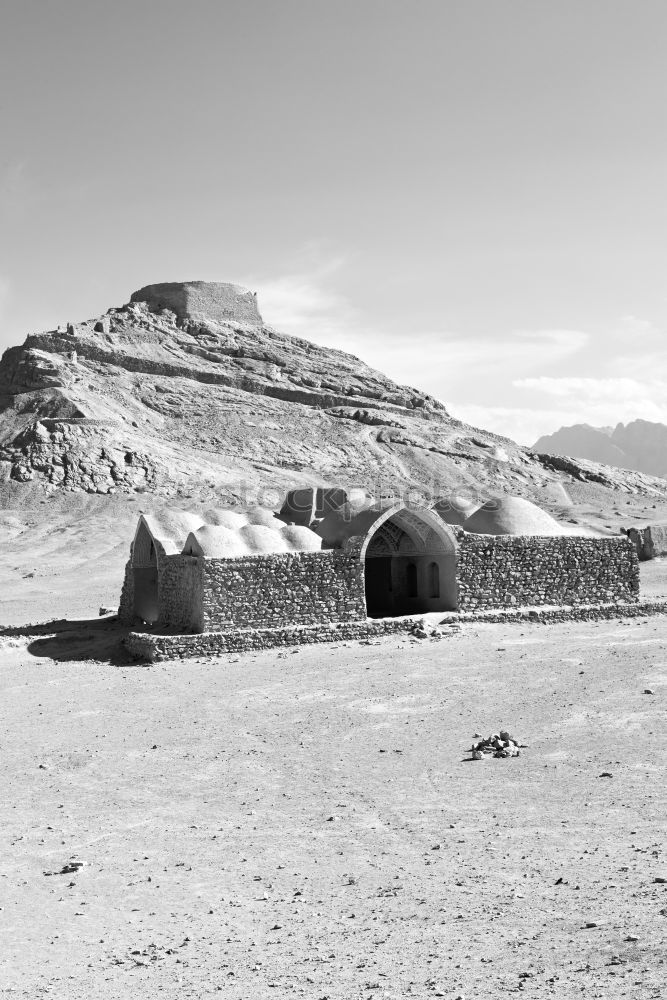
[532,420,667,477]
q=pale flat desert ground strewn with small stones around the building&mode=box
[0,540,667,1000]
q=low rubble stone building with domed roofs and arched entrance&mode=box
[119,492,639,645]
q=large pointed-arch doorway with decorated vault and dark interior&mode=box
[361,507,458,618]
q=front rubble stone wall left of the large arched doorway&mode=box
[202,551,366,631]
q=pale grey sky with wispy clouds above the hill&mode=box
[0,0,667,445]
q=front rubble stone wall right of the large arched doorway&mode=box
[458,534,639,611]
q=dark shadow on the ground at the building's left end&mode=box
[0,617,137,666]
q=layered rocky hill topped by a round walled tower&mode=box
[0,282,667,507]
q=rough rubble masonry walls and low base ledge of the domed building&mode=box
[120,532,640,657]
